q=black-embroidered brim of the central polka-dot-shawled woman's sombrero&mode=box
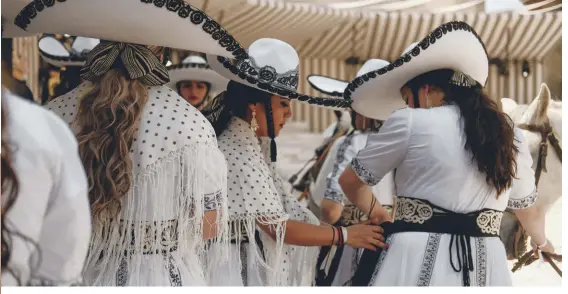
[207,54,351,109]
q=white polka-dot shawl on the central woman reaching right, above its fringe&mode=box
[219,118,286,220]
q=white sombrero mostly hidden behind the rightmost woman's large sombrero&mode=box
[308,59,389,97]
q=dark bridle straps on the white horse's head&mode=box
[517,121,562,186]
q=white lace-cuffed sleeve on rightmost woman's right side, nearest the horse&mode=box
[507,128,538,209]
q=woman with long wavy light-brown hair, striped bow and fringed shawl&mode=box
[5,0,248,286]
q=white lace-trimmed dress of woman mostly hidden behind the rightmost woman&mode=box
[314,131,395,286]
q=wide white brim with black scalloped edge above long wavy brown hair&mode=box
[2,0,246,59]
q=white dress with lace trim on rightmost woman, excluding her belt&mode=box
[351,105,537,286]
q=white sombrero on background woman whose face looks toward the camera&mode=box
[167,55,229,93]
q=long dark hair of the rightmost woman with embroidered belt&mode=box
[406,69,518,196]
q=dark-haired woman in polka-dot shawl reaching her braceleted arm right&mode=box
[204,39,382,286]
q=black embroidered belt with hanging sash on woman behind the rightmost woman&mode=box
[316,204,392,286]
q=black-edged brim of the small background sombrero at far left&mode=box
[38,36,87,67]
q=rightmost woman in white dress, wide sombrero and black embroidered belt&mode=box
[339,22,553,286]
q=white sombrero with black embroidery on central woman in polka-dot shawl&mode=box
[207,38,350,109]
